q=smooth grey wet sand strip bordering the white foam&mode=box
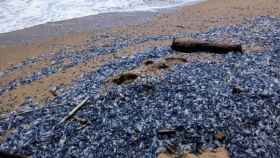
[0,11,159,45]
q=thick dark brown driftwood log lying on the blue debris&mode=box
[171,38,243,54]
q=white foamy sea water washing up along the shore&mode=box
[0,0,199,33]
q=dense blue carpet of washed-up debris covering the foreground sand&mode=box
[0,17,280,158]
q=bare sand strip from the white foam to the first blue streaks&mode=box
[0,0,280,70]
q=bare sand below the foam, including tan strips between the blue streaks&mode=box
[0,0,280,112]
